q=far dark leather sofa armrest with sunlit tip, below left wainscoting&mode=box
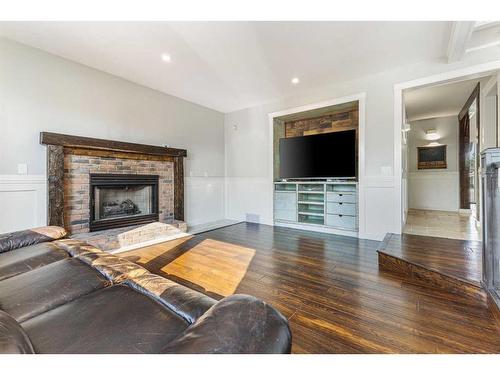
[0,226,67,253]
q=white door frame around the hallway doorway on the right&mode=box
[394,61,500,231]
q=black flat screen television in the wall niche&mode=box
[279,130,356,179]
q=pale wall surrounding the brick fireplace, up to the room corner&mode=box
[0,39,224,233]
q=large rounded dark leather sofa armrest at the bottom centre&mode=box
[161,294,292,354]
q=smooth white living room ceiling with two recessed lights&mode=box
[0,22,451,112]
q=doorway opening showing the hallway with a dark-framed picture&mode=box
[401,74,498,241]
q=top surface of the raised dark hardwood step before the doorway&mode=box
[379,234,482,286]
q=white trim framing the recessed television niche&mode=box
[268,92,366,238]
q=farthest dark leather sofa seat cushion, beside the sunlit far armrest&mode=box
[0,242,69,280]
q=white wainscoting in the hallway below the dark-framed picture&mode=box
[408,171,460,211]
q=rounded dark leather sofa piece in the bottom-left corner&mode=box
[0,310,34,354]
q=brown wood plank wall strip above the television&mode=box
[285,109,359,138]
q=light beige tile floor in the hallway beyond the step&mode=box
[403,209,481,241]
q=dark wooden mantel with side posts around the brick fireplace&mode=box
[40,132,187,226]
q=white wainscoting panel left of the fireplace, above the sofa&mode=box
[0,175,47,233]
